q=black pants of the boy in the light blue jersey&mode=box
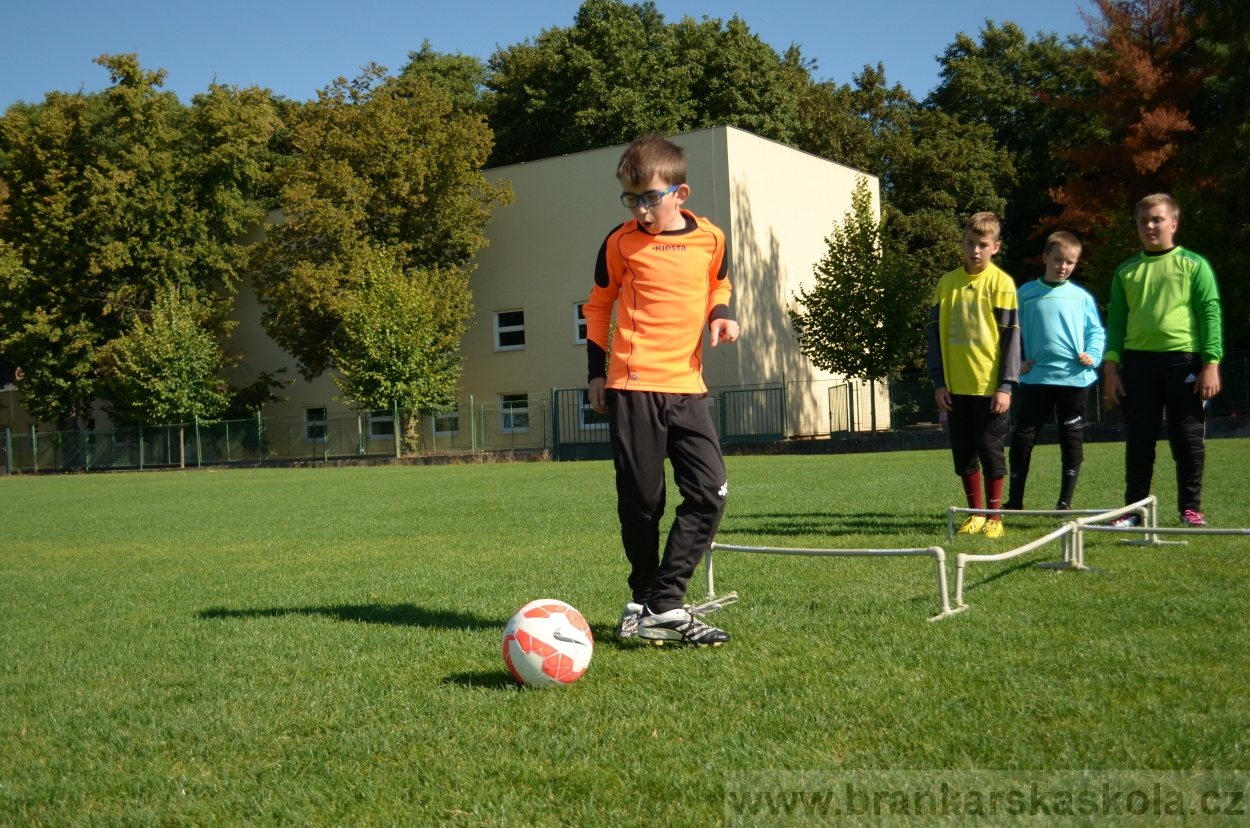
[1008,383,1089,507]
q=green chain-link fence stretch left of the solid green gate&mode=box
[0,400,551,474]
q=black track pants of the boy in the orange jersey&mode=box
[608,389,729,613]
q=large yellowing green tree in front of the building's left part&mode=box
[253,66,511,417]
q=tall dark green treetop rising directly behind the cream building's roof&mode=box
[486,0,810,164]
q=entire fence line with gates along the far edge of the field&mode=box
[0,351,1250,474]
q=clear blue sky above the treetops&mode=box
[0,0,1088,108]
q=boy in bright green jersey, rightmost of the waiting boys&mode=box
[1103,193,1224,527]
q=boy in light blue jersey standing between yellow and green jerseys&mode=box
[1003,231,1106,509]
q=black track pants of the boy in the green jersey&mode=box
[1120,350,1206,512]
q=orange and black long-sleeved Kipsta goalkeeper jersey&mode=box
[583,210,731,394]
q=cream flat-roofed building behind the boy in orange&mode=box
[0,126,889,445]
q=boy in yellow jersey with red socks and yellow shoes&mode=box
[929,213,1020,538]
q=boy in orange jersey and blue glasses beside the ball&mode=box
[584,135,739,645]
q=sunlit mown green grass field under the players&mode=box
[0,440,1250,825]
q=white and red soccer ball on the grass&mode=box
[504,598,595,687]
